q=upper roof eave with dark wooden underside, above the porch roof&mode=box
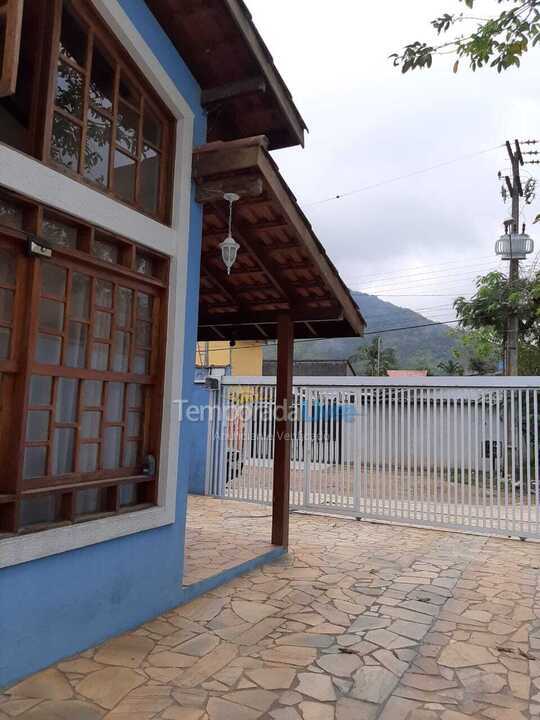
[146,0,307,149]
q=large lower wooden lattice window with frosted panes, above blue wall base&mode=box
[0,191,168,534]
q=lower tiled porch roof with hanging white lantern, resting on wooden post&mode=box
[193,137,365,340]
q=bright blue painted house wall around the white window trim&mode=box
[0,0,220,687]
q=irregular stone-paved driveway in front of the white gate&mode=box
[0,516,540,720]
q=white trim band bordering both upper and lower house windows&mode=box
[0,0,194,568]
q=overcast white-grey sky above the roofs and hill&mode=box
[248,0,540,320]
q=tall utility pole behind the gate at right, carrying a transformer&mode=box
[505,140,524,375]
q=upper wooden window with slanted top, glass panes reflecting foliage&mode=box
[49,0,172,220]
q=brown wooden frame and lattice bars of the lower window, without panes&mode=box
[0,190,169,537]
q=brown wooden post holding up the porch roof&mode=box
[272,313,294,547]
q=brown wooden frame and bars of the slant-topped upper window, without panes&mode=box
[43,0,176,224]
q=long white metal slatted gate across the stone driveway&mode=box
[207,378,540,538]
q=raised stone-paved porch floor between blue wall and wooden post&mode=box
[184,495,273,585]
